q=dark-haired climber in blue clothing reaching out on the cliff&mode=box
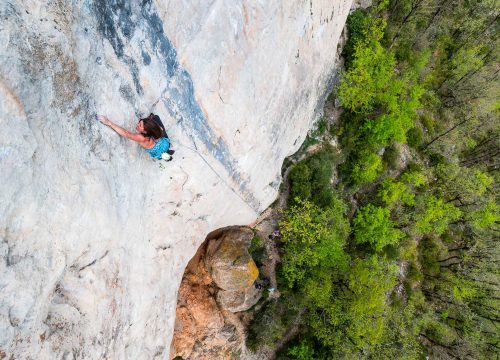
[96,113,174,161]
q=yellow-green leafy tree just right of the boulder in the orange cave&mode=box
[280,199,349,287]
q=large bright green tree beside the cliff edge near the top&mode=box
[338,14,424,148]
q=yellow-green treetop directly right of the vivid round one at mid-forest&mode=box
[415,195,462,235]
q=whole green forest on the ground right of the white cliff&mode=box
[247,0,500,359]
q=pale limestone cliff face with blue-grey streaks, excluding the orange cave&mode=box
[0,0,351,359]
